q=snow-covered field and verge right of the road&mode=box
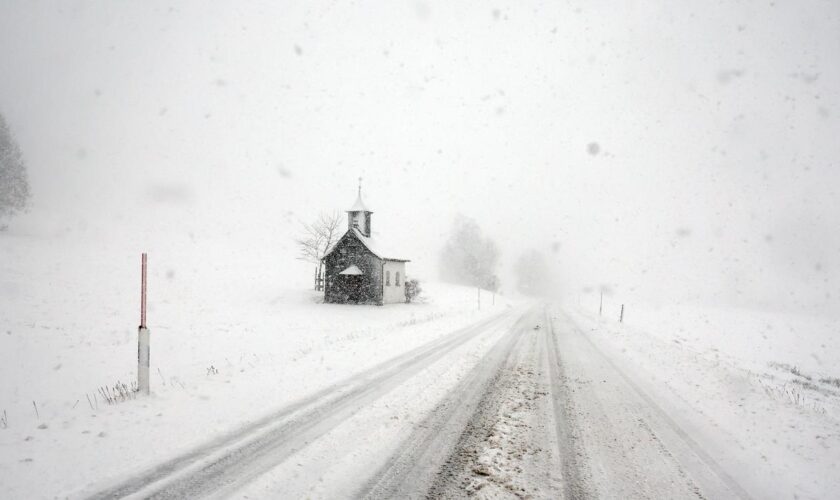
[568,307,840,498]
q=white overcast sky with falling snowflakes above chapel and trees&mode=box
[0,0,840,312]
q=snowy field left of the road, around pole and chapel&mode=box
[0,229,509,498]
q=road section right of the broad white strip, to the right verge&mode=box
[364,308,750,500]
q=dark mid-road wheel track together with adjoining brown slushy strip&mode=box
[355,309,564,499]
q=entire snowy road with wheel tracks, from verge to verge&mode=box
[91,306,749,499]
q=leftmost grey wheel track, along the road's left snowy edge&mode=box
[83,310,517,499]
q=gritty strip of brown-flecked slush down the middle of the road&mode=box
[428,311,564,499]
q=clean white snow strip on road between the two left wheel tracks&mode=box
[230,314,519,498]
